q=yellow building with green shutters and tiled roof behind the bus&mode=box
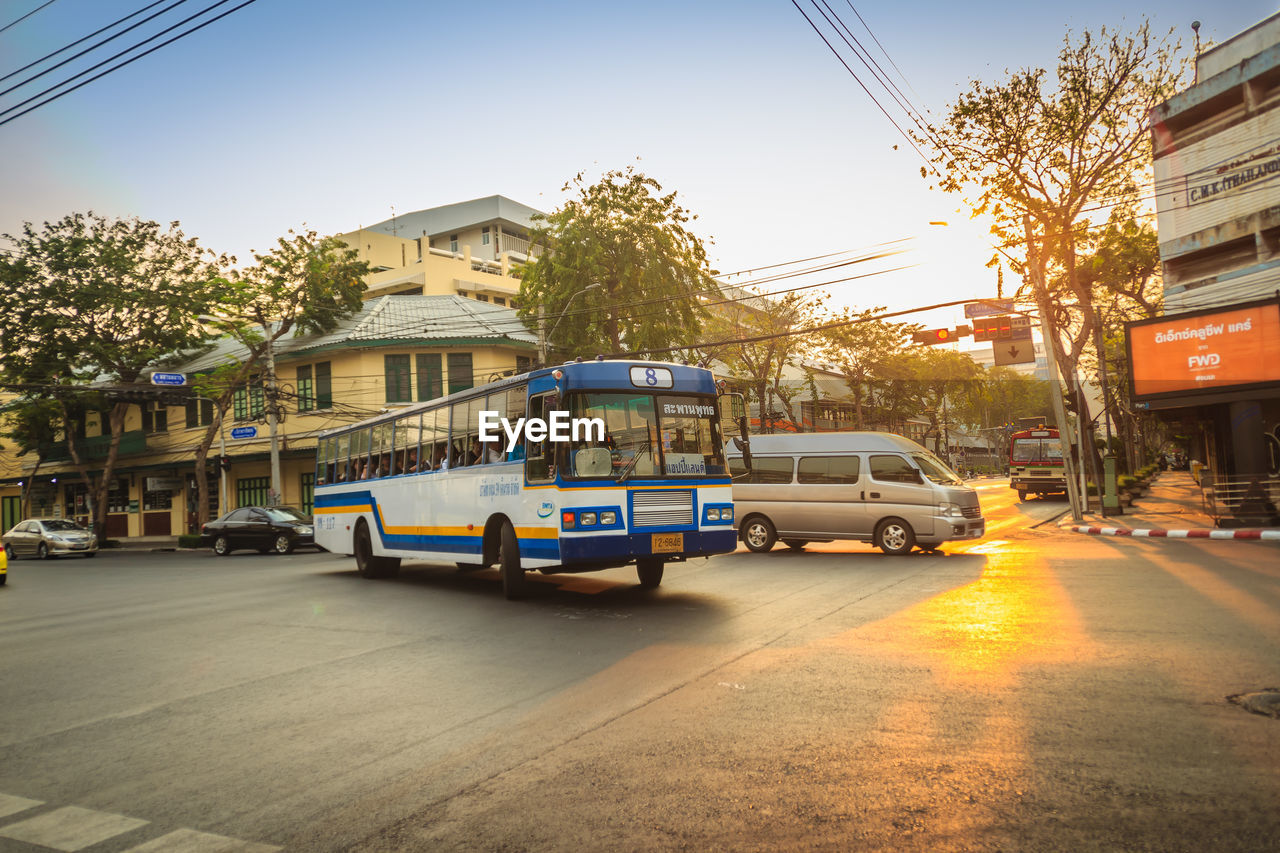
[0,196,536,538]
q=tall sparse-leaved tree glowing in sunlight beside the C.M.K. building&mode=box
[919,24,1180,512]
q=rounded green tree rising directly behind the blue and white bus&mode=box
[520,167,719,357]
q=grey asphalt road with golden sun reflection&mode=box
[0,482,1280,853]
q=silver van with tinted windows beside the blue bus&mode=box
[726,432,986,555]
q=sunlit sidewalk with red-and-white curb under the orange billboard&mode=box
[1059,471,1280,540]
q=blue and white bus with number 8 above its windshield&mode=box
[314,360,745,598]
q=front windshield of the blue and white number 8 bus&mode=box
[563,392,726,482]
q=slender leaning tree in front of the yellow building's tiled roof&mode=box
[176,231,369,524]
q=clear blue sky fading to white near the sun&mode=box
[0,0,1275,323]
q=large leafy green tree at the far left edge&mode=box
[0,211,228,535]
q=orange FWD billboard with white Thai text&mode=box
[1125,298,1280,401]
